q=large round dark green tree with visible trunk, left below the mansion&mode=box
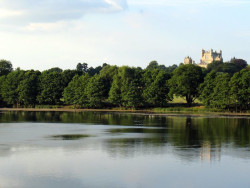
[168,64,203,106]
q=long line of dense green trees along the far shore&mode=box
[0,58,250,111]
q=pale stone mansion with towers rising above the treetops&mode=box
[184,49,223,68]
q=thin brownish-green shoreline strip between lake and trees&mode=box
[0,108,250,117]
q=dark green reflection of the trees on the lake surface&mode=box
[0,112,250,159]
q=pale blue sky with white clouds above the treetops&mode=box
[0,0,250,71]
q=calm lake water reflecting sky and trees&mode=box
[0,112,250,188]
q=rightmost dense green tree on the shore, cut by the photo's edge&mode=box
[229,69,250,111]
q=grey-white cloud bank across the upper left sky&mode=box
[0,0,127,23]
